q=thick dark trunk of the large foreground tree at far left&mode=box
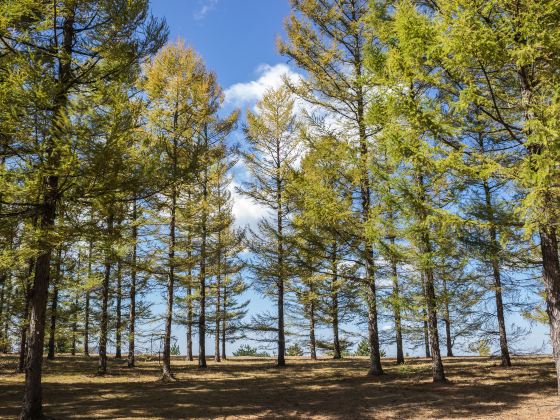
[20,8,74,420]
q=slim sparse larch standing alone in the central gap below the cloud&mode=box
[240,88,300,366]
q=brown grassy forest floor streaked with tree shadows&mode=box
[0,355,560,420]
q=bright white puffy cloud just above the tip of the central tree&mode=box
[225,64,301,107]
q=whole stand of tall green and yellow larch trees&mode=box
[0,0,560,418]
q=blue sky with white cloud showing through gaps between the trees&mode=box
[140,0,548,356]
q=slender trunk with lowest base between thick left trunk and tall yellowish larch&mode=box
[97,210,113,375]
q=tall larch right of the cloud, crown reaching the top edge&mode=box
[278,0,383,375]
